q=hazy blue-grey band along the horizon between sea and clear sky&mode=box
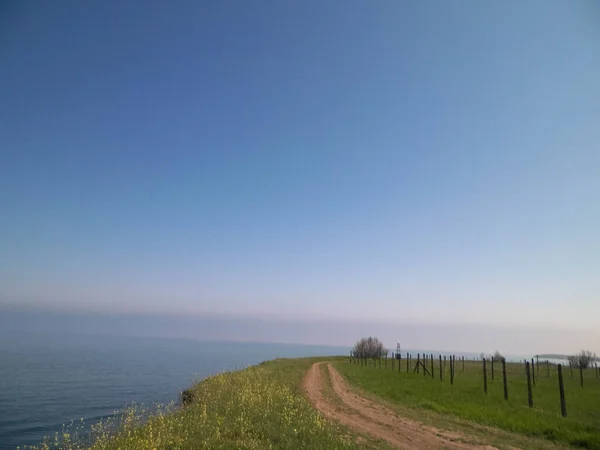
[0,304,600,355]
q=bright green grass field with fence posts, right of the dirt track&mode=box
[336,359,600,449]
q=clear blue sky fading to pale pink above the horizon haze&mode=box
[0,0,600,353]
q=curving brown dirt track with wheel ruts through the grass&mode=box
[304,363,495,450]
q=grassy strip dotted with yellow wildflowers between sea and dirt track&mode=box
[28,359,379,450]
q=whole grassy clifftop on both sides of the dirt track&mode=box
[23,358,600,450]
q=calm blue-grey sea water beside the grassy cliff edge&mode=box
[0,335,347,450]
